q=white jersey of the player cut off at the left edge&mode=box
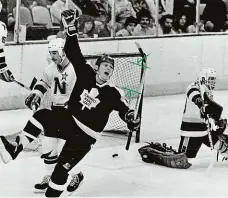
[0,21,7,73]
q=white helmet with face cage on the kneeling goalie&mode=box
[199,67,216,90]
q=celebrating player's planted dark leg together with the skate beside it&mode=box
[45,120,96,197]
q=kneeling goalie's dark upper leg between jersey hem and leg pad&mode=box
[178,136,202,158]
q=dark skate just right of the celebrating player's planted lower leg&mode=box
[67,172,84,196]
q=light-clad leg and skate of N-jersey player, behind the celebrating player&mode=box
[34,136,59,193]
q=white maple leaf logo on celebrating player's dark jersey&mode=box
[80,88,100,110]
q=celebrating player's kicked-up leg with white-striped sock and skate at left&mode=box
[0,109,58,163]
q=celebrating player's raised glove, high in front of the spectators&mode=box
[62,10,80,36]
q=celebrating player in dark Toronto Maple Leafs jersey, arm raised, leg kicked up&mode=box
[0,10,140,197]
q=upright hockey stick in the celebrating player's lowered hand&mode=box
[125,42,147,151]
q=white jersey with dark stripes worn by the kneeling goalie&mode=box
[181,83,214,137]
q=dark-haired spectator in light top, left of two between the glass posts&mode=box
[116,16,137,36]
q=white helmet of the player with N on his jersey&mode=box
[48,38,65,59]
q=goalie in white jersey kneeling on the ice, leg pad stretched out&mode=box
[139,68,228,169]
